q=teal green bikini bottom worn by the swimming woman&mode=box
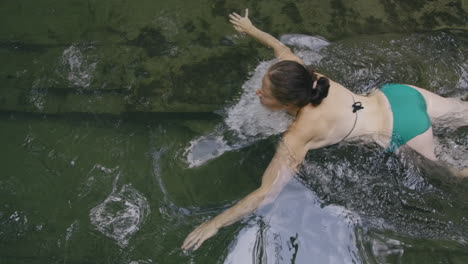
[381,84,431,152]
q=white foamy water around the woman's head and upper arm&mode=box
[185,34,329,167]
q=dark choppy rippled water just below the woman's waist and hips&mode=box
[300,146,466,243]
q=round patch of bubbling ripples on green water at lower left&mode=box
[89,177,150,247]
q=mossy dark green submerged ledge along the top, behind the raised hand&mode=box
[0,0,468,114]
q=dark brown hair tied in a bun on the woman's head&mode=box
[267,60,330,107]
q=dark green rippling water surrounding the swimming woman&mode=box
[0,0,468,264]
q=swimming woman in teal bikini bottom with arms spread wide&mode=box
[182,9,468,250]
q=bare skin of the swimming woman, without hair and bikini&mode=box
[182,9,468,250]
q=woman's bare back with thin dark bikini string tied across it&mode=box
[296,81,393,150]
